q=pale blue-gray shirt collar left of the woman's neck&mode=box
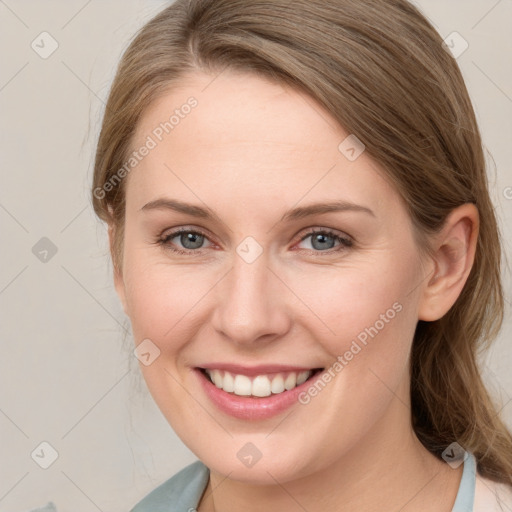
[130,461,210,512]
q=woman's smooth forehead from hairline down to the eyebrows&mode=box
[127,71,396,216]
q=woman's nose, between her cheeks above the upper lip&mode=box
[212,249,291,346]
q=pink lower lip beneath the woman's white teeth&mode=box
[194,368,321,420]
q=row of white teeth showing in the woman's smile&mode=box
[206,369,313,397]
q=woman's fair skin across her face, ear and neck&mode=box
[110,71,478,512]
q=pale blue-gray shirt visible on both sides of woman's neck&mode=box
[130,453,512,512]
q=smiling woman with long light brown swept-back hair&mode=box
[93,0,512,512]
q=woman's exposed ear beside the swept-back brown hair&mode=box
[418,203,479,322]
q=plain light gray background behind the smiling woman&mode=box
[0,0,512,512]
